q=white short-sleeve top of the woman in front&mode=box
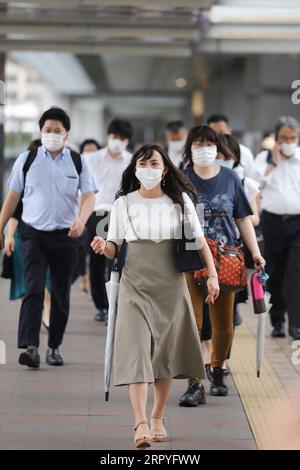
[107,190,204,245]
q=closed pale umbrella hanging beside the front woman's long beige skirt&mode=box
[104,261,120,401]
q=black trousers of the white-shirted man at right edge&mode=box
[261,211,300,327]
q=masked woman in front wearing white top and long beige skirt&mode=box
[92,145,219,448]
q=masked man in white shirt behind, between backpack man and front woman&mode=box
[84,119,133,321]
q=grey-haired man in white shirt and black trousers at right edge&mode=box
[261,118,300,339]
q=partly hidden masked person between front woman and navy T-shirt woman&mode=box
[166,120,188,170]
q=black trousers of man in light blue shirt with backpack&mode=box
[18,224,78,348]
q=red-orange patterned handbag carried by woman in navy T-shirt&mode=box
[194,238,247,292]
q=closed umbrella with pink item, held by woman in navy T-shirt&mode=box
[251,267,269,377]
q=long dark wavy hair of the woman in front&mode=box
[116,144,197,210]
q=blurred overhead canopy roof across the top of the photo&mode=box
[0,0,300,97]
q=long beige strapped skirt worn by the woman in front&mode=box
[114,240,205,385]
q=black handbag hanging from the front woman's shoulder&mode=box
[176,217,205,273]
